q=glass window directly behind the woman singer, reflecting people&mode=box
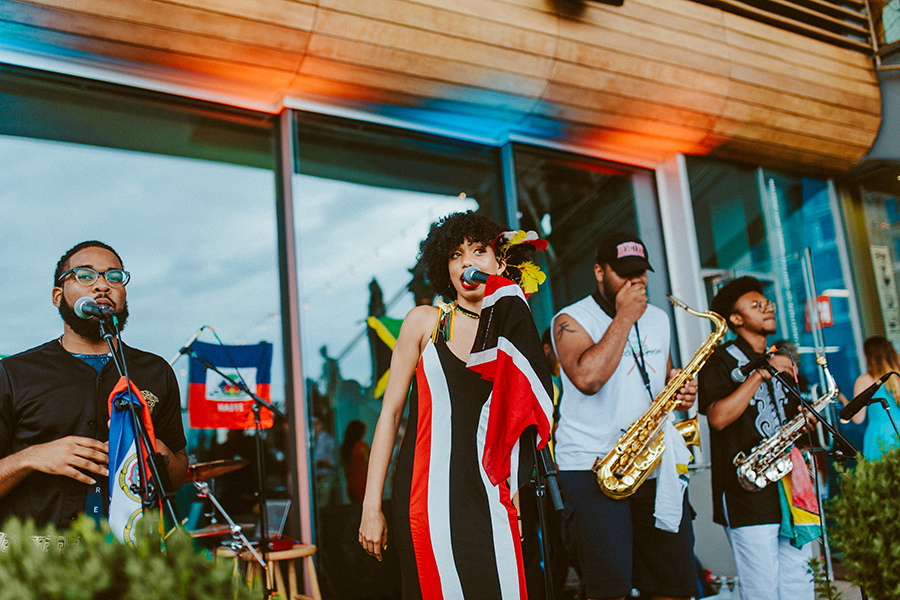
[292,114,506,598]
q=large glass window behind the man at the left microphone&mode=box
[0,71,288,543]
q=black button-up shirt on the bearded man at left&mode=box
[0,340,186,528]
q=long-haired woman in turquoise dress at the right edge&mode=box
[852,335,900,460]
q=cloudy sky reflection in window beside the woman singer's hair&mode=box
[294,175,478,386]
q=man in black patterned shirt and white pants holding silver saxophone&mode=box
[698,277,814,600]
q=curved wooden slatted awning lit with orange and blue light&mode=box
[0,0,881,172]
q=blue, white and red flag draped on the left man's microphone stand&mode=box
[107,377,156,545]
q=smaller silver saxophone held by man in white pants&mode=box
[734,352,838,492]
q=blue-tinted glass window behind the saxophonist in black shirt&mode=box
[687,157,859,404]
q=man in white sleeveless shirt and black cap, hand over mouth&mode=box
[552,234,698,599]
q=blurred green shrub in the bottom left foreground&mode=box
[0,515,260,600]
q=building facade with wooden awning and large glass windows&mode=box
[0,0,900,598]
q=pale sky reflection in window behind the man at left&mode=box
[0,136,284,401]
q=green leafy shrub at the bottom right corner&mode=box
[831,448,900,600]
